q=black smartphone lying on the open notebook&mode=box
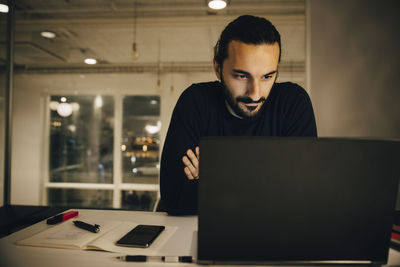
[116,224,165,248]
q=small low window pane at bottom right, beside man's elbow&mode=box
[121,190,157,211]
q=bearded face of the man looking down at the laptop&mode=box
[214,41,279,118]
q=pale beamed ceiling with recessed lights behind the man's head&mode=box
[0,0,305,73]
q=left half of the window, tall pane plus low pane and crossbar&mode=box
[46,95,114,208]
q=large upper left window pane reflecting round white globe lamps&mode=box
[49,96,114,183]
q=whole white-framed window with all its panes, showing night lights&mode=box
[45,95,161,210]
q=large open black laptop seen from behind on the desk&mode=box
[197,137,400,265]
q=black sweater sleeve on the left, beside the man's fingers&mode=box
[160,85,201,215]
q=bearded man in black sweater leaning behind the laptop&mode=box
[160,15,317,215]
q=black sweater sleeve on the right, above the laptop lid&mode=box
[283,83,317,137]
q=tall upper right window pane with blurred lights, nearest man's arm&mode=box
[121,96,161,184]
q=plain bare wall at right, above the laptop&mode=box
[307,0,400,138]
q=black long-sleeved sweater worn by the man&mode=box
[160,82,317,215]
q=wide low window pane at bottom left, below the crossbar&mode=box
[47,188,113,208]
